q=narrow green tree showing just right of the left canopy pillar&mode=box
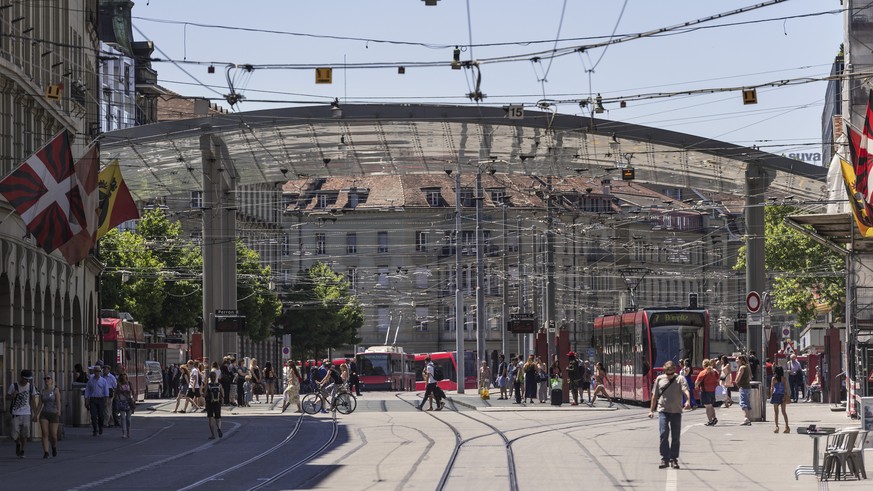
[236,241,282,341]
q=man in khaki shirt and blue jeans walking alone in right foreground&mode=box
[644,360,691,469]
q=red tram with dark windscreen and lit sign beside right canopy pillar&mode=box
[592,308,709,403]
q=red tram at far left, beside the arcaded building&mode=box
[100,317,148,400]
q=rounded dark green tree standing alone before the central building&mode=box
[280,262,364,357]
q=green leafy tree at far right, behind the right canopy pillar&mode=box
[734,206,846,326]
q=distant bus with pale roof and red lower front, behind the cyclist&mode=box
[355,346,415,391]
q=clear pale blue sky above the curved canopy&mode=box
[133,0,844,165]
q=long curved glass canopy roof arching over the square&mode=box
[101,105,827,205]
